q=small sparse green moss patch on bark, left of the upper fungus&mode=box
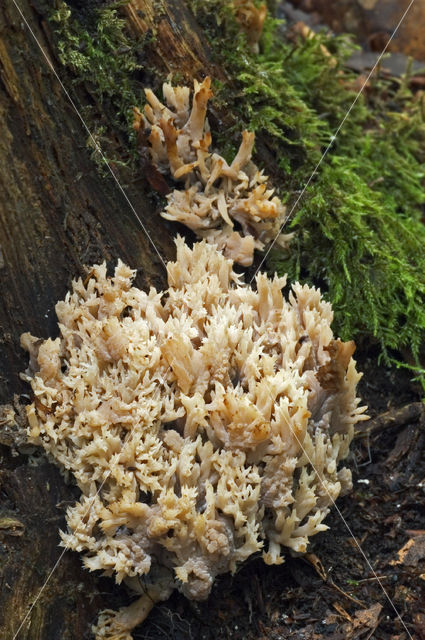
[50,2,148,168]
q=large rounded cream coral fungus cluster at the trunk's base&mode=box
[22,238,364,638]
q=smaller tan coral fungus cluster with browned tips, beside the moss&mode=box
[134,77,293,266]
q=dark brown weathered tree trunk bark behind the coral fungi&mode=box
[0,0,219,640]
